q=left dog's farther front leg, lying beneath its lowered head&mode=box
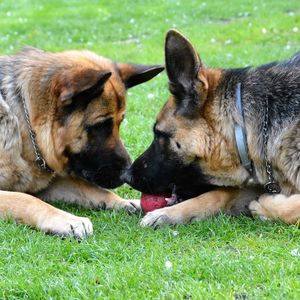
[39,178,140,213]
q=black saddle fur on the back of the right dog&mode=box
[219,54,300,132]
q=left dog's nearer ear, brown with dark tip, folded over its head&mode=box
[57,69,111,104]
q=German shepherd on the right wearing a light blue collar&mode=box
[124,30,300,227]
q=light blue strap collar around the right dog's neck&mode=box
[234,82,253,175]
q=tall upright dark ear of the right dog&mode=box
[165,29,201,108]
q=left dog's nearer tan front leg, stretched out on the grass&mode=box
[0,191,93,239]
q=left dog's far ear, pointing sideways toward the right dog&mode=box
[117,63,165,89]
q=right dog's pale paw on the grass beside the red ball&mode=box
[140,207,181,228]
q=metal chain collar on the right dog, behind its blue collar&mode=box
[263,96,281,194]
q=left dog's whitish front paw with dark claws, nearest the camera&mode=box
[39,213,93,239]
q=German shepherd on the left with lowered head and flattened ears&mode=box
[0,48,163,238]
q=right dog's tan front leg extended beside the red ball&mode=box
[140,189,238,227]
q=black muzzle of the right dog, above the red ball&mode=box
[126,131,213,199]
